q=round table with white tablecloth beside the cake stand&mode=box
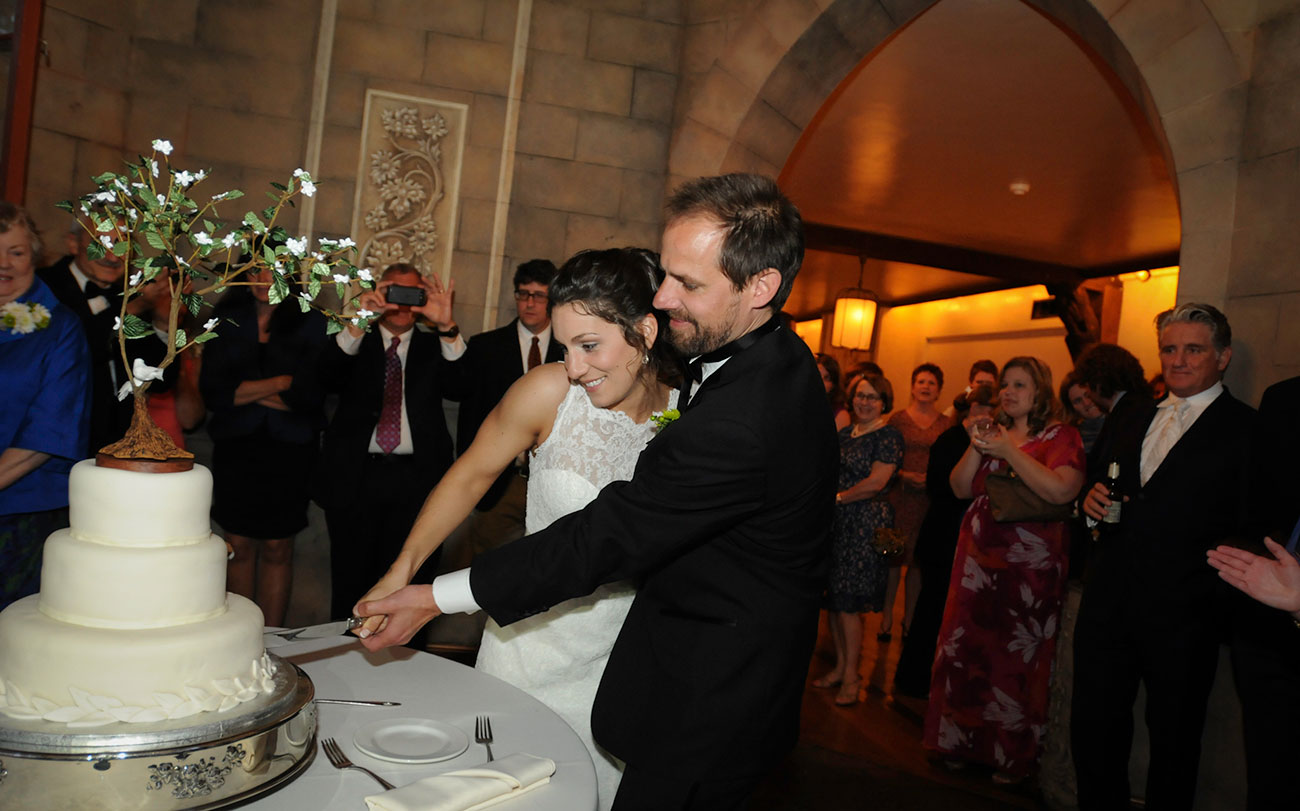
[242,637,597,811]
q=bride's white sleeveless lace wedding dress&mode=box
[476,386,677,810]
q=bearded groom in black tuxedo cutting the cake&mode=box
[359,174,839,811]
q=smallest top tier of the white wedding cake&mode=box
[68,459,212,546]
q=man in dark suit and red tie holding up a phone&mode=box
[315,264,464,616]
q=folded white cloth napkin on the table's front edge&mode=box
[365,753,555,811]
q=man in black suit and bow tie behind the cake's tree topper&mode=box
[36,225,131,455]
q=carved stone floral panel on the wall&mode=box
[352,90,468,279]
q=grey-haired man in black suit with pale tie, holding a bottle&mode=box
[1071,303,1256,811]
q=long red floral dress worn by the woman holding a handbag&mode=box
[924,425,1084,776]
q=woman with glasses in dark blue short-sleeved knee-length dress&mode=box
[813,374,902,707]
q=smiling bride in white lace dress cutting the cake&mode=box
[354,248,677,808]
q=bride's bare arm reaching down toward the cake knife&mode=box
[354,364,569,633]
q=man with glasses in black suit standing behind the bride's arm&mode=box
[449,259,564,565]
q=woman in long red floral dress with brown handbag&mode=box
[924,357,1084,782]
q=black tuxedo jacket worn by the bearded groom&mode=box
[471,329,839,784]
